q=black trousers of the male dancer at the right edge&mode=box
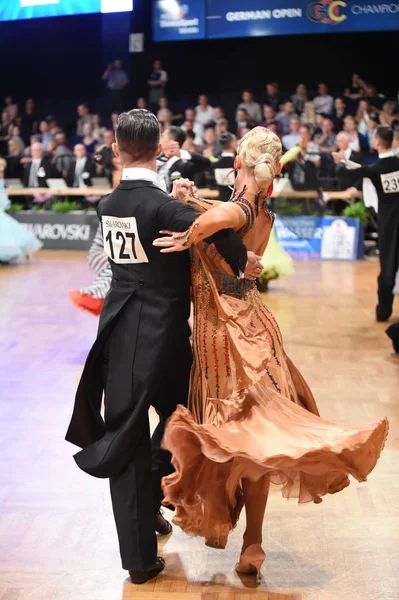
[377,215,399,320]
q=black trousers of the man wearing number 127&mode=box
[102,342,191,570]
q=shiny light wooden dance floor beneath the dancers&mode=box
[0,252,399,600]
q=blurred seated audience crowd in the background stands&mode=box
[0,71,399,199]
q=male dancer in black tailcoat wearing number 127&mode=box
[66,110,258,583]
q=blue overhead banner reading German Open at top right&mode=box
[153,0,399,41]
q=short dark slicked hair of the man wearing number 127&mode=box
[116,108,160,162]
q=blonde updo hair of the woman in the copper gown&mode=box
[238,127,282,192]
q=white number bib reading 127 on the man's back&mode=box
[102,217,149,265]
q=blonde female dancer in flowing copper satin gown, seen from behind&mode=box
[152,127,388,575]
